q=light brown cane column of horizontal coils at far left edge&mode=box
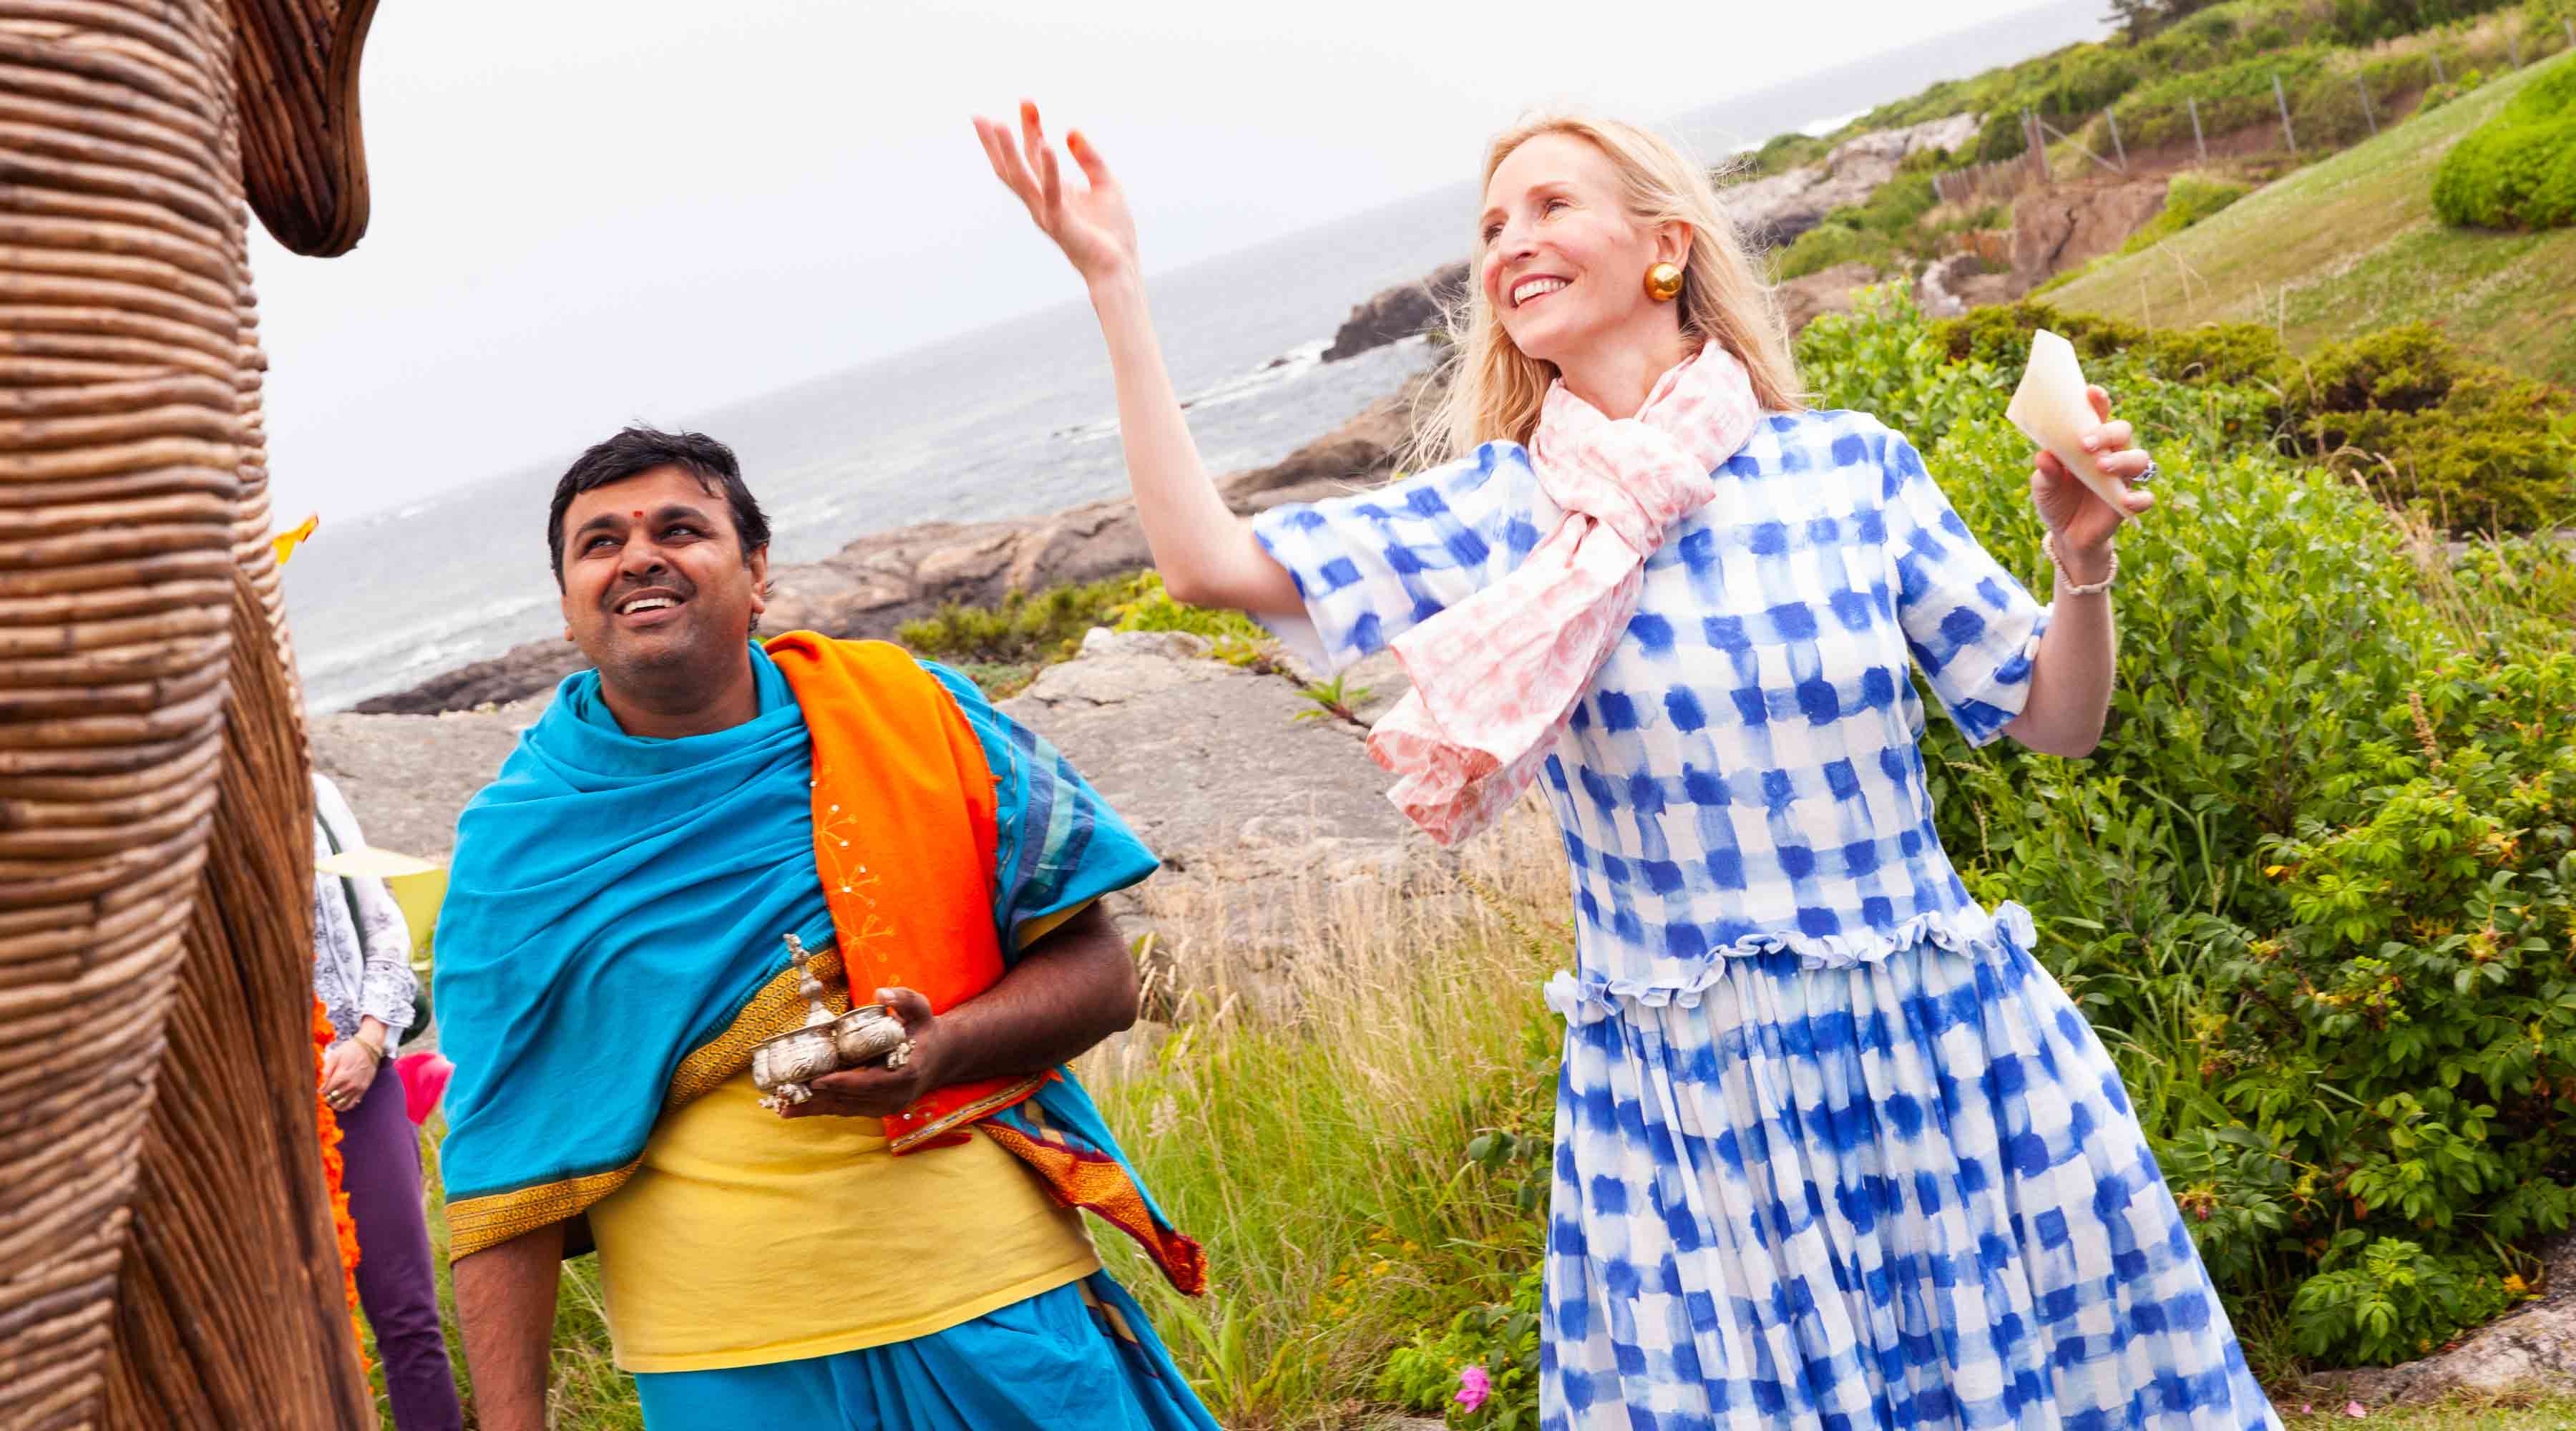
[0,0,248,1431]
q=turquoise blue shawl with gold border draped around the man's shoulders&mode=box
[435,646,1159,1251]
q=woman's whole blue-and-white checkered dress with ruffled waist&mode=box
[1254,412,2280,1431]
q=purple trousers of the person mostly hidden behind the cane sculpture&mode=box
[340,1060,464,1431]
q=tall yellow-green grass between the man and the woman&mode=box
[1085,801,1571,1428]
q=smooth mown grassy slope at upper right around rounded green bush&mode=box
[2048,54,2576,384]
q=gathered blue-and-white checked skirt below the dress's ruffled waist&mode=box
[1541,906,2280,1431]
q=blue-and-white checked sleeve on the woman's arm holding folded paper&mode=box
[1883,432,2048,746]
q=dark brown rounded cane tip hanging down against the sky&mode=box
[227,0,376,258]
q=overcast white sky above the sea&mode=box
[253,0,2032,525]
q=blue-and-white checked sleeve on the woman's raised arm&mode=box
[1252,443,1546,672]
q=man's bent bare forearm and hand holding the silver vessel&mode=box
[789,904,1138,1117]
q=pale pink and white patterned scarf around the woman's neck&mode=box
[1368,342,1762,844]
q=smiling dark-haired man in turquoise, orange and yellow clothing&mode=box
[435,427,1214,1431]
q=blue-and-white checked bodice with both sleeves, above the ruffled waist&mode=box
[1254,412,2048,1012]
